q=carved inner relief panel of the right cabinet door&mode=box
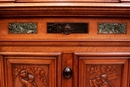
[86,64,123,87]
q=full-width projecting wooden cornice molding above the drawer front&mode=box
[0,3,130,17]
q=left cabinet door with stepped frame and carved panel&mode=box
[0,53,61,87]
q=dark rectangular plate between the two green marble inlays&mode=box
[47,23,88,33]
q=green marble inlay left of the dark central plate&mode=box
[8,22,37,34]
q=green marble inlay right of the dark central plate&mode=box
[98,23,127,34]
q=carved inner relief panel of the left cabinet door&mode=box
[13,65,48,87]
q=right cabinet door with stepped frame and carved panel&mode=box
[73,54,129,87]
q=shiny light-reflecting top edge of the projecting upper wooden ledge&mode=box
[0,3,130,8]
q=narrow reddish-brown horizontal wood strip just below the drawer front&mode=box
[0,41,130,47]
